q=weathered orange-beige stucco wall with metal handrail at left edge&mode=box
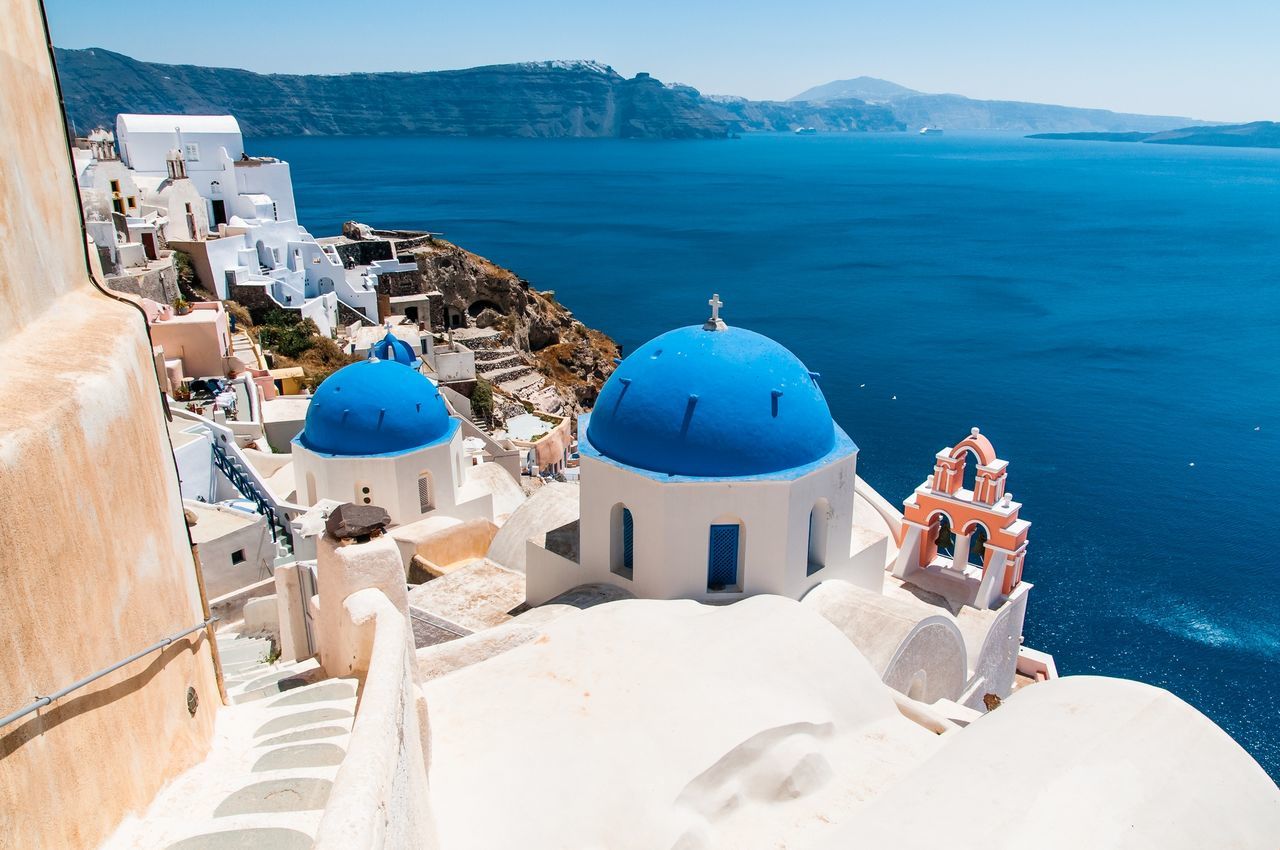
[0,0,219,847]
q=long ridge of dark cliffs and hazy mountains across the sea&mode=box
[55,47,1213,138]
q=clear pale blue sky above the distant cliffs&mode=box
[45,0,1280,120]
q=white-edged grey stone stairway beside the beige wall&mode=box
[102,631,356,850]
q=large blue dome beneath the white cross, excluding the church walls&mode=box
[586,325,836,477]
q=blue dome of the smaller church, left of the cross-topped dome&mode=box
[296,360,456,457]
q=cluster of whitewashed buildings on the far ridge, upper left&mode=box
[76,114,378,335]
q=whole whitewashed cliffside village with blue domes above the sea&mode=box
[0,38,1280,850]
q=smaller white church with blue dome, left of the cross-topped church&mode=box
[293,350,493,525]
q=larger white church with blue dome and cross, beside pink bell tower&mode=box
[527,298,884,604]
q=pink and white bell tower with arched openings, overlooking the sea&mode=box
[893,428,1030,608]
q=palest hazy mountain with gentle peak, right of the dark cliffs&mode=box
[787,77,1203,132]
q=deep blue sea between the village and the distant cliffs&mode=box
[262,133,1280,777]
